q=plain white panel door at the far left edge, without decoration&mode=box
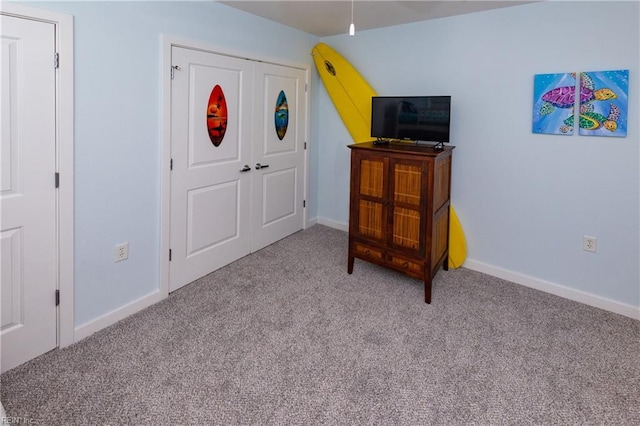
[0,15,58,372]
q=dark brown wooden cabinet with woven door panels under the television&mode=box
[348,142,453,303]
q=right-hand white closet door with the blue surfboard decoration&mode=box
[251,63,307,252]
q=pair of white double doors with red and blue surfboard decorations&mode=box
[164,45,308,292]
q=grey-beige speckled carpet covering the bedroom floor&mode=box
[0,225,640,425]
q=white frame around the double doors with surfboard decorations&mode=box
[159,35,311,297]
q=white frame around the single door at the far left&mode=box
[0,2,75,347]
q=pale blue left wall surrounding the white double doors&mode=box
[29,1,317,331]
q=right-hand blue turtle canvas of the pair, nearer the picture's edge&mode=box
[578,70,629,138]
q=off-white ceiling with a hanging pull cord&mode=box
[218,0,540,37]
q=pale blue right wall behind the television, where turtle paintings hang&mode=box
[316,2,640,311]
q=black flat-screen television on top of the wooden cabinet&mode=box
[371,96,451,142]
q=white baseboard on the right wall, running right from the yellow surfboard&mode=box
[462,259,640,320]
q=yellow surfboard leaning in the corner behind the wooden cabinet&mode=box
[311,43,467,268]
